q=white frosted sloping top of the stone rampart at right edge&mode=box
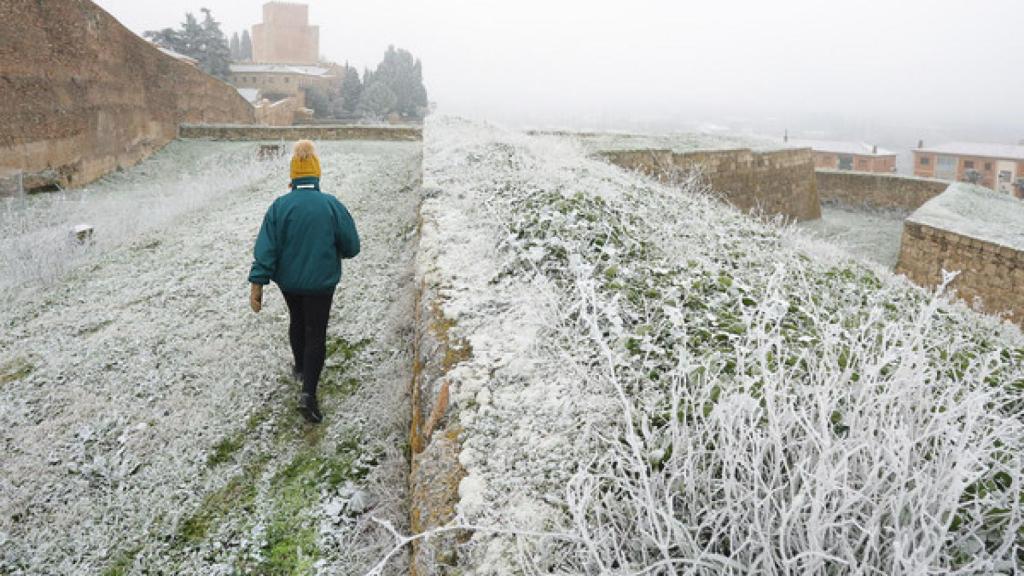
[907,182,1024,250]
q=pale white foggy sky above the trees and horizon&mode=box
[98,0,1024,140]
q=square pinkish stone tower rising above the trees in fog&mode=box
[253,2,319,65]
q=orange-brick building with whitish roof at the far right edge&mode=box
[913,142,1024,198]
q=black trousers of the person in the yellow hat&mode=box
[285,292,334,396]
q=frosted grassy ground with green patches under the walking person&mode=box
[0,141,420,575]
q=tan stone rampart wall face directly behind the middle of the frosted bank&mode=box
[600,149,821,220]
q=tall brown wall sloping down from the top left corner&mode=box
[0,0,255,192]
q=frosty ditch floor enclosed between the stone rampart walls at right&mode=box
[797,206,906,270]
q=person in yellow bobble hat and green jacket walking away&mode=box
[249,140,359,423]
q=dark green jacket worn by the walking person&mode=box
[249,178,359,294]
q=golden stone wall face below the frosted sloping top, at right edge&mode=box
[896,220,1024,326]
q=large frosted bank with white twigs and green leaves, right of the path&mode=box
[421,119,1024,574]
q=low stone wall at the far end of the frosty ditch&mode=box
[816,170,949,212]
